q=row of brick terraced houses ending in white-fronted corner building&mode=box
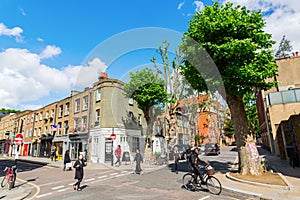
[0,73,145,162]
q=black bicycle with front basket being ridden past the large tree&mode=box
[182,164,222,195]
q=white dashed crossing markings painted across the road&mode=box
[35,171,132,199]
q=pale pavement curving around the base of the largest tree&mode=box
[216,148,300,200]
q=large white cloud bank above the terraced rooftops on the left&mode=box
[0,48,107,108]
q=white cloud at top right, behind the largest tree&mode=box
[224,0,300,51]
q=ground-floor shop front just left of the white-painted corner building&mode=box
[68,133,88,160]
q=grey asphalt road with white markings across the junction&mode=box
[1,146,258,200]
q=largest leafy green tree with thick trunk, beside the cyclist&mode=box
[181,2,277,175]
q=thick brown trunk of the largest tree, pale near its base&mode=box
[227,95,261,175]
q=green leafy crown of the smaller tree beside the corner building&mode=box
[124,68,168,119]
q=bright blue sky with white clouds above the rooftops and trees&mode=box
[0,0,300,110]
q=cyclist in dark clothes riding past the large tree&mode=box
[189,147,207,184]
